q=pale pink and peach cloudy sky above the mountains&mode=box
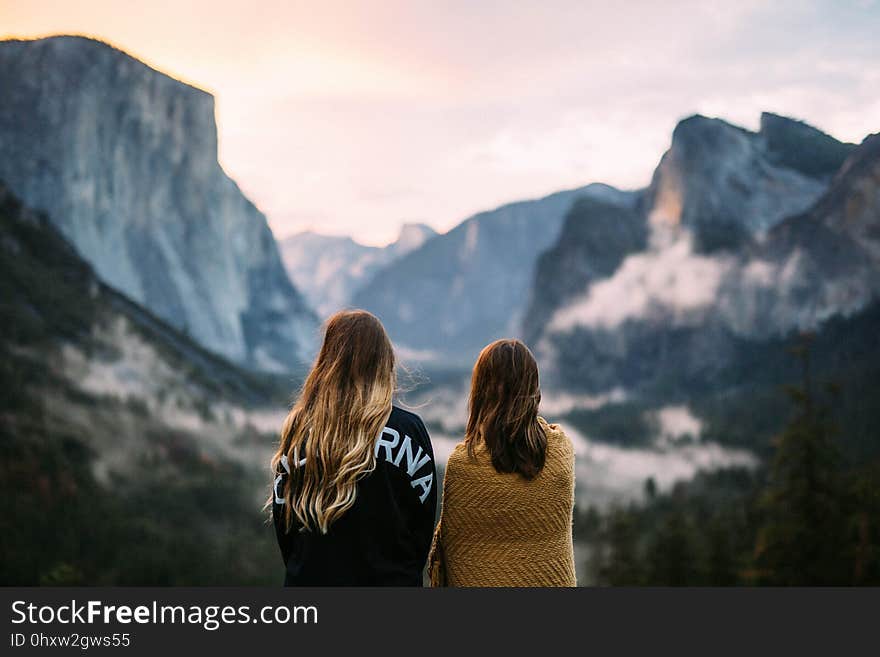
[0,0,880,244]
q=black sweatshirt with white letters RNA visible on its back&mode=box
[272,406,437,586]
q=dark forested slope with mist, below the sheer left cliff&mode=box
[0,183,292,585]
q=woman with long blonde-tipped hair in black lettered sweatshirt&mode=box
[270,310,437,586]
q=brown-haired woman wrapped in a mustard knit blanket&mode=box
[429,340,576,586]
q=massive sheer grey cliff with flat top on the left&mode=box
[0,36,316,370]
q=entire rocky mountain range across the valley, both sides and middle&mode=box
[0,37,880,391]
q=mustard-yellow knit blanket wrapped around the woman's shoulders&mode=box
[428,418,576,586]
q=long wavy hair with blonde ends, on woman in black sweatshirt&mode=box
[272,310,396,534]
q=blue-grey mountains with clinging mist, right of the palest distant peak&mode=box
[344,113,874,374]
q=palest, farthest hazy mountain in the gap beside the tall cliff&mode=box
[278,223,436,317]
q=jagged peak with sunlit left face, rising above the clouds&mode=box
[646,114,848,252]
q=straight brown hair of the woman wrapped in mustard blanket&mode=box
[464,340,547,479]
